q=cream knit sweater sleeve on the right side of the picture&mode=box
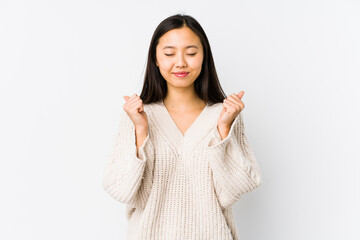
[207,112,262,208]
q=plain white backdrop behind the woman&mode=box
[0,0,360,240]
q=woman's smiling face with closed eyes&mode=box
[156,27,203,87]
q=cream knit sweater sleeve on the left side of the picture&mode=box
[102,111,154,208]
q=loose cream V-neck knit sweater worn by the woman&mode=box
[103,101,262,240]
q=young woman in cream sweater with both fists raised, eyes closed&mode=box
[103,14,262,240]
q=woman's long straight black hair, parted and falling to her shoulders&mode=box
[140,14,226,105]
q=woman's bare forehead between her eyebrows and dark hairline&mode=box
[158,27,201,49]
